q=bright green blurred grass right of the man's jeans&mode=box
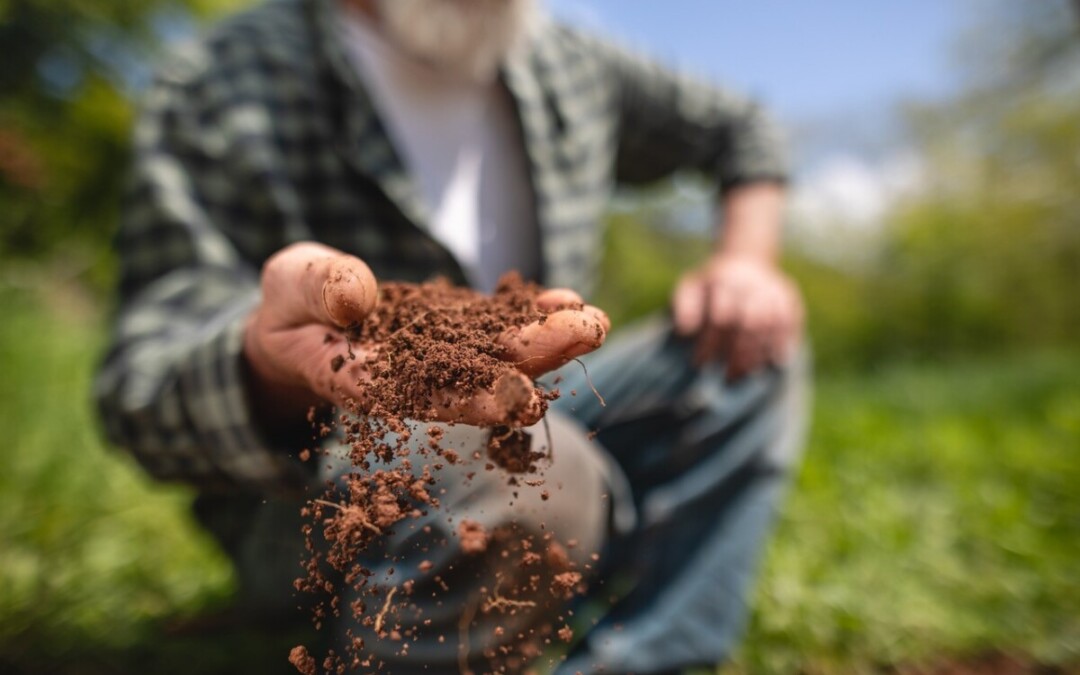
[739,353,1080,673]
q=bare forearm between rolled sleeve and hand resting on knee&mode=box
[714,180,786,262]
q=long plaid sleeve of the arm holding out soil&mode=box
[94,48,303,492]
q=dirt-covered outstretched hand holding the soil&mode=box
[243,243,610,426]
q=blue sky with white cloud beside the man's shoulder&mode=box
[548,0,977,236]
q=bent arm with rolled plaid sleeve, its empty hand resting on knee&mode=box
[599,31,802,378]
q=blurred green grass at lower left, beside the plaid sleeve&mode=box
[0,284,231,672]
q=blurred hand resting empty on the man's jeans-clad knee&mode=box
[673,255,804,380]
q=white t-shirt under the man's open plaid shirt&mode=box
[341,9,540,292]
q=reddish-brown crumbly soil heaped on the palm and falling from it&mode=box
[289,274,584,675]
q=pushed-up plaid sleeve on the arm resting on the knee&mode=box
[597,34,787,190]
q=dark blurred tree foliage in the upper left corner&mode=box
[0,0,252,287]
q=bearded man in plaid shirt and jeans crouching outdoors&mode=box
[97,0,802,673]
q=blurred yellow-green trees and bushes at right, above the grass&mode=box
[768,32,1080,367]
